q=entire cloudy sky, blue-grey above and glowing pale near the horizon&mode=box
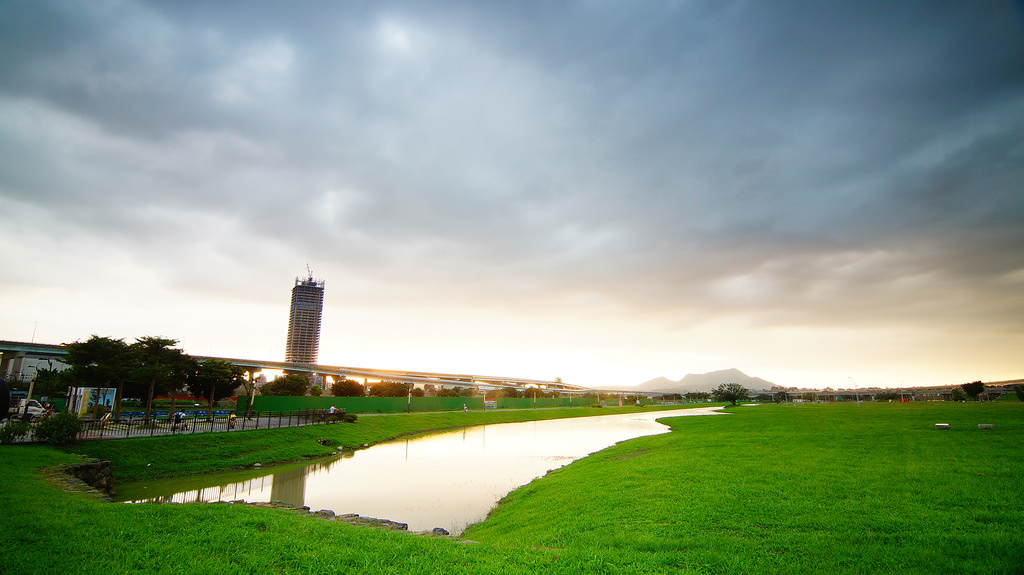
[0,0,1024,388]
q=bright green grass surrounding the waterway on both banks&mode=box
[0,403,1024,573]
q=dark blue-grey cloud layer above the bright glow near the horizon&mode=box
[0,2,1024,328]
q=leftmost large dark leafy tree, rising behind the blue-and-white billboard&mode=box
[61,335,132,419]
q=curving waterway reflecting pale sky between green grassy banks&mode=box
[117,408,714,534]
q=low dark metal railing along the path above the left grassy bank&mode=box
[78,409,344,439]
